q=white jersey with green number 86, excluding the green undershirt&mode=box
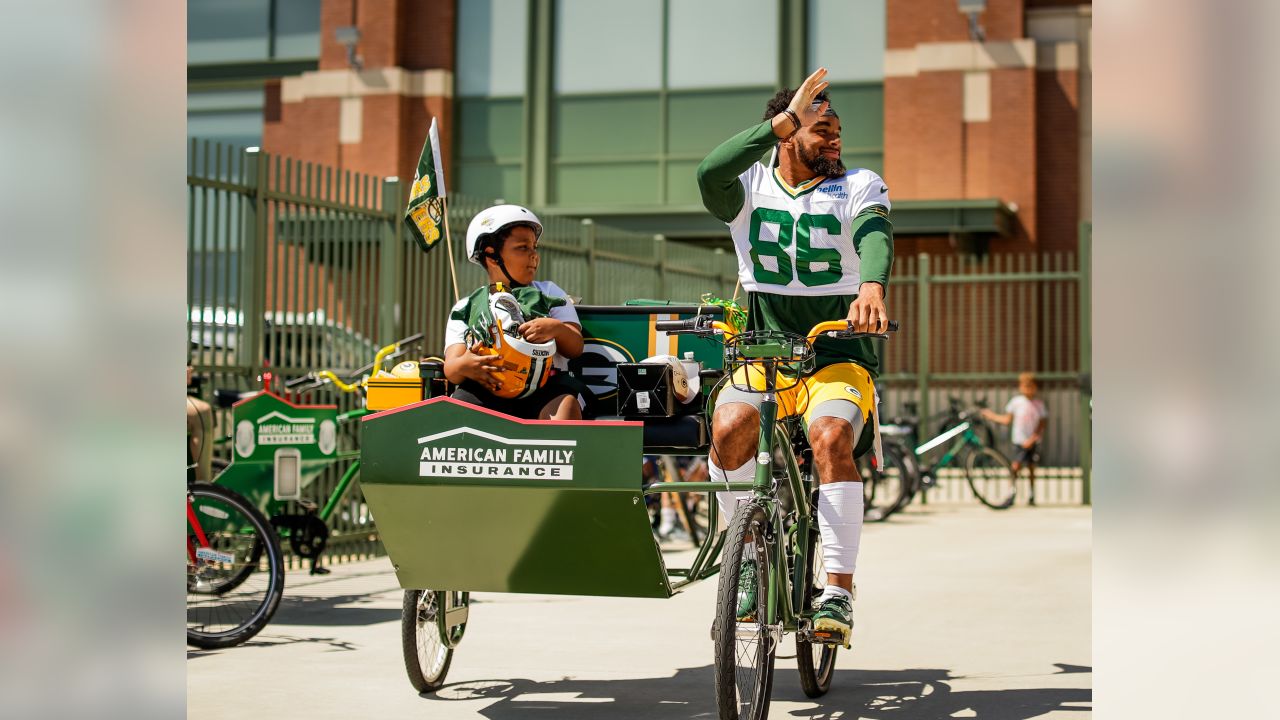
[728,163,890,294]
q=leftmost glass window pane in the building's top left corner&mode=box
[187,0,270,64]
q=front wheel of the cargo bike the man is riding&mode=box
[712,502,777,720]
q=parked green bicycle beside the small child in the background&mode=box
[881,396,1016,510]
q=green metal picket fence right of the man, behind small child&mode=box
[881,224,1092,503]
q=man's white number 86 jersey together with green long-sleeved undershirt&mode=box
[698,120,893,368]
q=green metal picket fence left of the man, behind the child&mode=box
[187,140,736,560]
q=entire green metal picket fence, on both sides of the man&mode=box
[187,140,1091,566]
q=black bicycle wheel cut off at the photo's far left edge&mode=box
[187,483,284,650]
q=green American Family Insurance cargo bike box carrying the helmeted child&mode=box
[360,299,722,598]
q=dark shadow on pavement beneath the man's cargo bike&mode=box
[422,664,1093,720]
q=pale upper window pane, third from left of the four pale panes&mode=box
[667,0,778,90]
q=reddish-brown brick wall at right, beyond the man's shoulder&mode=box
[884,0,1080,252]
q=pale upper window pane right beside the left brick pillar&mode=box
[457,0,529,97]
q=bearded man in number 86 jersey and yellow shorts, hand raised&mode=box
[698,68,893,644]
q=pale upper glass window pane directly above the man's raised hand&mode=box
[805,0,884,83]
